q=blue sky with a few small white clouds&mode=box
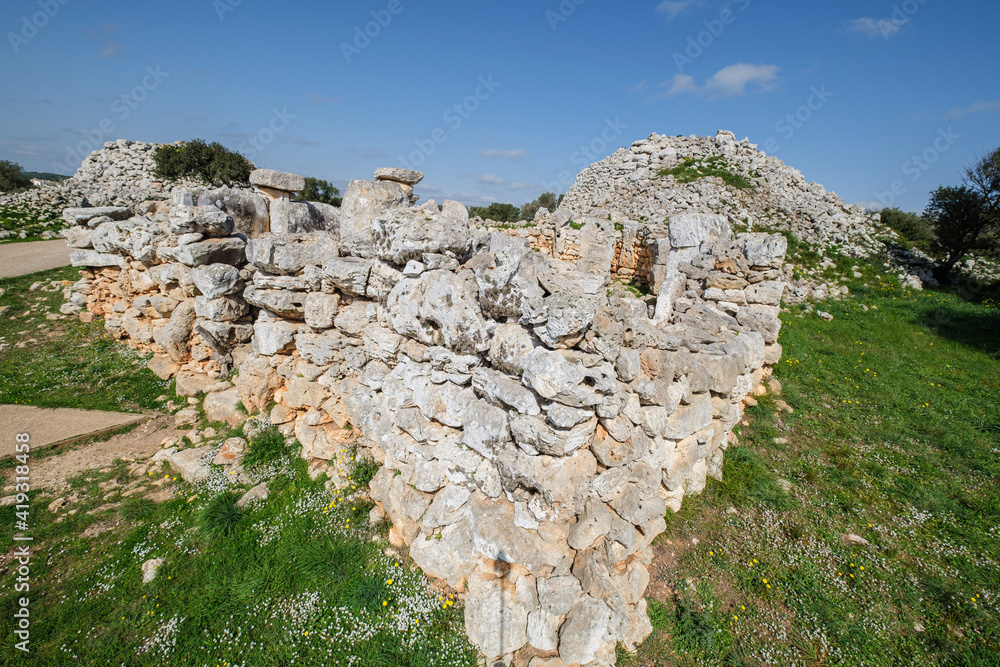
[0,0,1000,210]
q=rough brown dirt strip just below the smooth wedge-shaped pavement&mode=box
[5,415,181,494]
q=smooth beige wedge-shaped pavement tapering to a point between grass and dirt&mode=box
[0,405,150,458]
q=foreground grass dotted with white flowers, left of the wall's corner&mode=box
[0,436,476,667]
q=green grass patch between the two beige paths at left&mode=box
[0,268,173,412]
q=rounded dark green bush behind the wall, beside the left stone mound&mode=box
[154,139,254,186]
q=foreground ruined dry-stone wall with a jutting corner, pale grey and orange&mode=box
[65,144,786,666]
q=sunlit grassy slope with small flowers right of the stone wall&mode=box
[623,267,1000,667]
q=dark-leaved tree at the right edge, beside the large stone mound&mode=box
[924,148,1000,278]
